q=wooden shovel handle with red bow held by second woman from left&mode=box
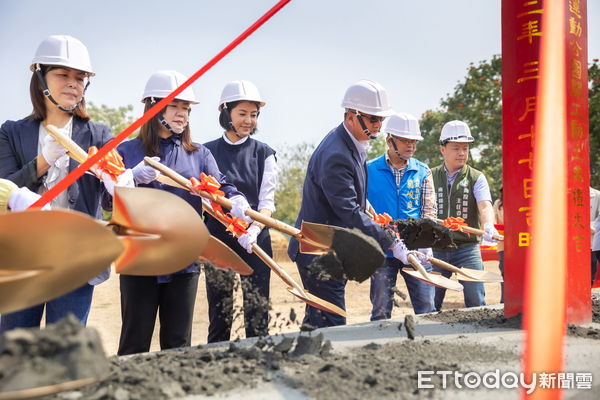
[144,157,303,239]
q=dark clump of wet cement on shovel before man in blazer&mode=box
[308,228,385,282]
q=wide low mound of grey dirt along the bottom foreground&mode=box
[39,335,518,400]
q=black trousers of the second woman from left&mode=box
[118,273,199,356]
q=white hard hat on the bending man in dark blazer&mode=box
[342,79,393,117]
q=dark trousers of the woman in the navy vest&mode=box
[205,226,273,343]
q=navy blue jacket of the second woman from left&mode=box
[110,135,241,283]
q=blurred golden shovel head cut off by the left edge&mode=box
[0,210,123,313]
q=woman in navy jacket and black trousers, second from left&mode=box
[108,71,251,355]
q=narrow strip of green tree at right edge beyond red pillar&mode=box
[588,59,600,189]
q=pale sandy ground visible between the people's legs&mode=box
[88,239,500,355]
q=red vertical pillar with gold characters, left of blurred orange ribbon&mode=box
[502,0,543,317]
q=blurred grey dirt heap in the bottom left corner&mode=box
[0,315,110,392]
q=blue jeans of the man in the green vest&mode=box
[433,243,485,311]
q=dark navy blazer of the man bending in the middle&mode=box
[288,124,392,261]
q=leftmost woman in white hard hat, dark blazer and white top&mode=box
[0,35,112,331]
